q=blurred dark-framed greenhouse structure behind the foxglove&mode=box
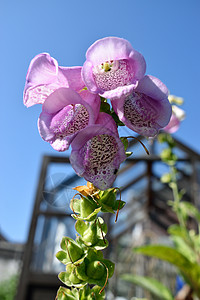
[15,137,200,300]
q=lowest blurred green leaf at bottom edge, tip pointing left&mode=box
[121,274,174,300]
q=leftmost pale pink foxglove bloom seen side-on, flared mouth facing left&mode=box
[24,53,85,107]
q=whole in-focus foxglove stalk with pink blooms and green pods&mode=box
[23,37,172,300]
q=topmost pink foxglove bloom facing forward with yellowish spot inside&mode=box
[82,37,146,99]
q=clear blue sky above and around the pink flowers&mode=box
[0,0,200,242]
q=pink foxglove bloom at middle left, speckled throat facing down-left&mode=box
[38,87,100,151]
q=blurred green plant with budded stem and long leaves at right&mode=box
[122,133,200,300]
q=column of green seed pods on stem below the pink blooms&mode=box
[56,186,125,300]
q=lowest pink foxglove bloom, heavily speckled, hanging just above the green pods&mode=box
[70,113,126,190]
